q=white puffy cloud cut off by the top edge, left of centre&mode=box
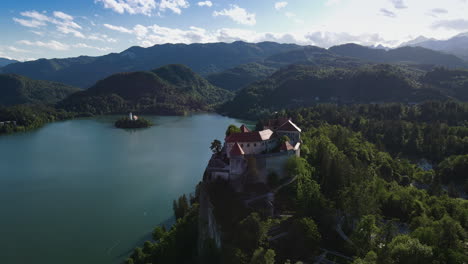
[95,0,190,16]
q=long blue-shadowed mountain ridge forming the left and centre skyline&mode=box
[1,42,300,88]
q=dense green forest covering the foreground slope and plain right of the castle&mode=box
[126,101,468,264]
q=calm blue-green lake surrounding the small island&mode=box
[0,114,249,264]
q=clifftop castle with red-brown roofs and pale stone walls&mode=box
[204,118,302,191]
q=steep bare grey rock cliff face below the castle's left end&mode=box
[198,183,221,252]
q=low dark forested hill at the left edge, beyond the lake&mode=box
[0,74,80,106]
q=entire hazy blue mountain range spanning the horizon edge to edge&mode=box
[0,41,468,90]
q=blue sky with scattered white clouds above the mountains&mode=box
[0,0,468,61]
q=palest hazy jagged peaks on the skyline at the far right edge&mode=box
[401,33,468,60]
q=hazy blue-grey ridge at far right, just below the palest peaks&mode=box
[328,44,468,68]
